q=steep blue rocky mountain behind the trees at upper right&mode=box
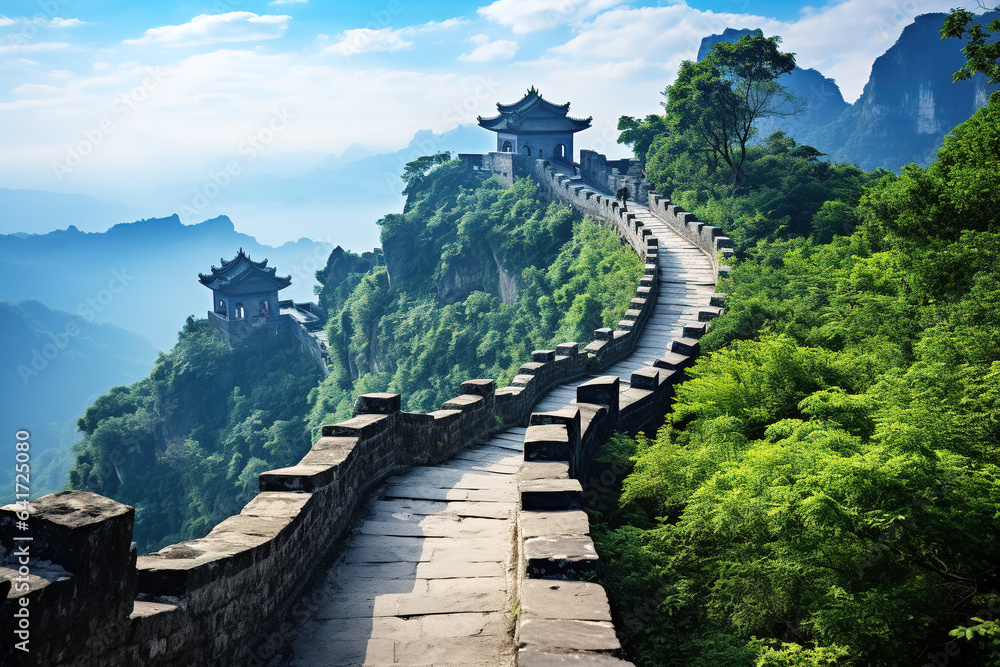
[698,11,1000,171]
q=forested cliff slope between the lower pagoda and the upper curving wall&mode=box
[310,161,642,427]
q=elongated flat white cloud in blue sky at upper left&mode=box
[124,12,292,46]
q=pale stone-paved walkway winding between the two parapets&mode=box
[282,167,715,667]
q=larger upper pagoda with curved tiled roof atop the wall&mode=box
[477,86,594,163]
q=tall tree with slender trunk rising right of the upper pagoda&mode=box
[664,35,795,189]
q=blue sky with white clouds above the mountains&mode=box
[0,0,972,217]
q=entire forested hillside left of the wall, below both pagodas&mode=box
[70,160,642,552]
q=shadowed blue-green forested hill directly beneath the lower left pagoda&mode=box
[70,317,321,553]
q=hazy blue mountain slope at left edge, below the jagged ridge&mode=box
[0,301,156,503]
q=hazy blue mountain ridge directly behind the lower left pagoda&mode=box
[0,216,332,352]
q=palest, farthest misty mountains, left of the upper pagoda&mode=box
[0,125,495,252]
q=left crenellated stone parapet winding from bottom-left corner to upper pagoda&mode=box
[0,154,672,667]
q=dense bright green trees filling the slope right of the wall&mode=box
[595,90,1000,667]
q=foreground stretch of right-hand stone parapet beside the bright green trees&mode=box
[517,370,697,667]
